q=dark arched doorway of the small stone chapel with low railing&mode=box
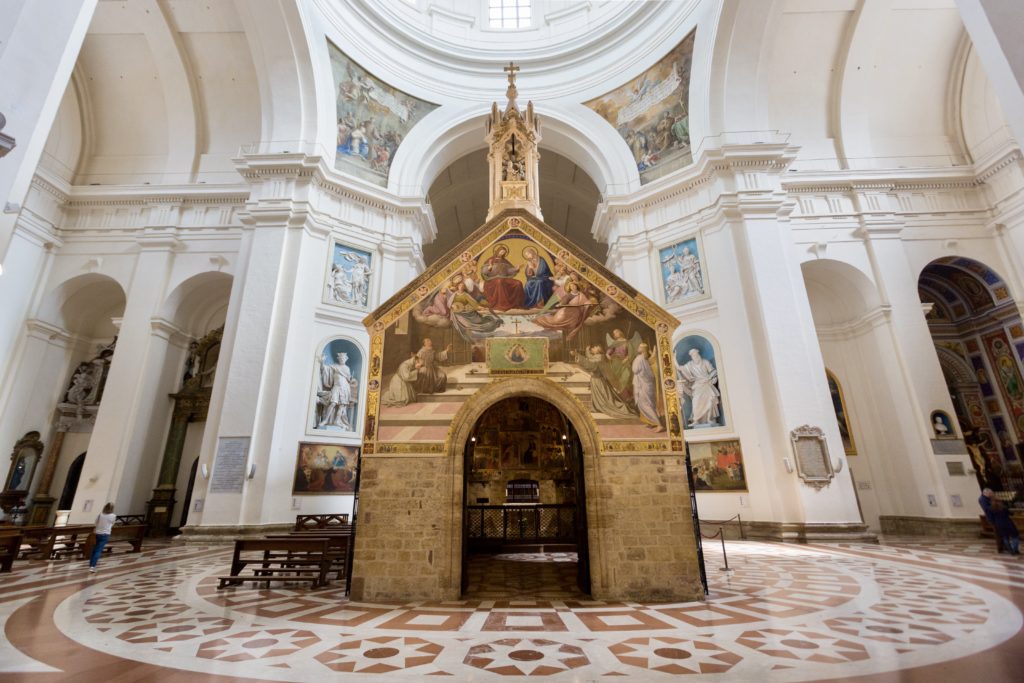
[462,396,590,598]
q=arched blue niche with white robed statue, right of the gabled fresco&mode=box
[675,335,725,429]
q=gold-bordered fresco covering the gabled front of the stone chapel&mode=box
[365,217,681,456]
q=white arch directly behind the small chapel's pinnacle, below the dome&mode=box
[388,102,640,197]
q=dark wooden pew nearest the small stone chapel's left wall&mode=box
[217,538,332,589]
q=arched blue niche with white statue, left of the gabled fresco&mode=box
[310,339,362,432]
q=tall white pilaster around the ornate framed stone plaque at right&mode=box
[720,147,860,524]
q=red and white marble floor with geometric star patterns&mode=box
[0,540,1024,683]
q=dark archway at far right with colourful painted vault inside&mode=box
[918,257,1024,490]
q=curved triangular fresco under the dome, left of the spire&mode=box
[328,43,437,186]
